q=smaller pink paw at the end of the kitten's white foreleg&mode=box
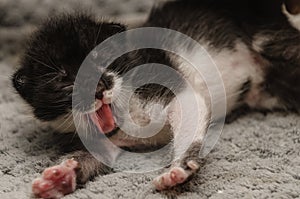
[153,160,200,191]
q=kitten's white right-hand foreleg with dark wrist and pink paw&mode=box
[153,93,210,190]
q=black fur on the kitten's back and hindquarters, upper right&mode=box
[145,0,300,110]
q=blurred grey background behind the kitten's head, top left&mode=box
[0,0,155,60]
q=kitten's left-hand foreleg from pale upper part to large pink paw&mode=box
[32,127,151,198]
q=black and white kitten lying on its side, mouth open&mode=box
[13,0,300,198]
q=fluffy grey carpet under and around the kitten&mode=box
[0,0,300,199]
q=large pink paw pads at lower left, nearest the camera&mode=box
[32,159,78,199]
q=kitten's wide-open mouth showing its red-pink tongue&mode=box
[89,100,116,134]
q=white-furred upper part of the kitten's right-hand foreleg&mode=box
[168,89,210,159]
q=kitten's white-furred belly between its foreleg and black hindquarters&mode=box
[174,42,278,113]
